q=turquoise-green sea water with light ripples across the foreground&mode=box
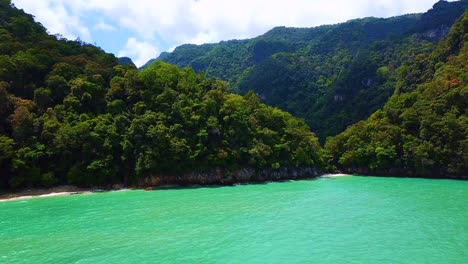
[0,177,468,263]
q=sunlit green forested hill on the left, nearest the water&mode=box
[0,0,323,188]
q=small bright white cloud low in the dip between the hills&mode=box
[118,38,158,67]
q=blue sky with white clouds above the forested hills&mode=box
[12,0,450,66]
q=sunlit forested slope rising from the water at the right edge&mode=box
[326,11,468,178]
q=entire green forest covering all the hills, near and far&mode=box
[0,0,468,189]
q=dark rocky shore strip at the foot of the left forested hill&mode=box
[140,167,321,186]
